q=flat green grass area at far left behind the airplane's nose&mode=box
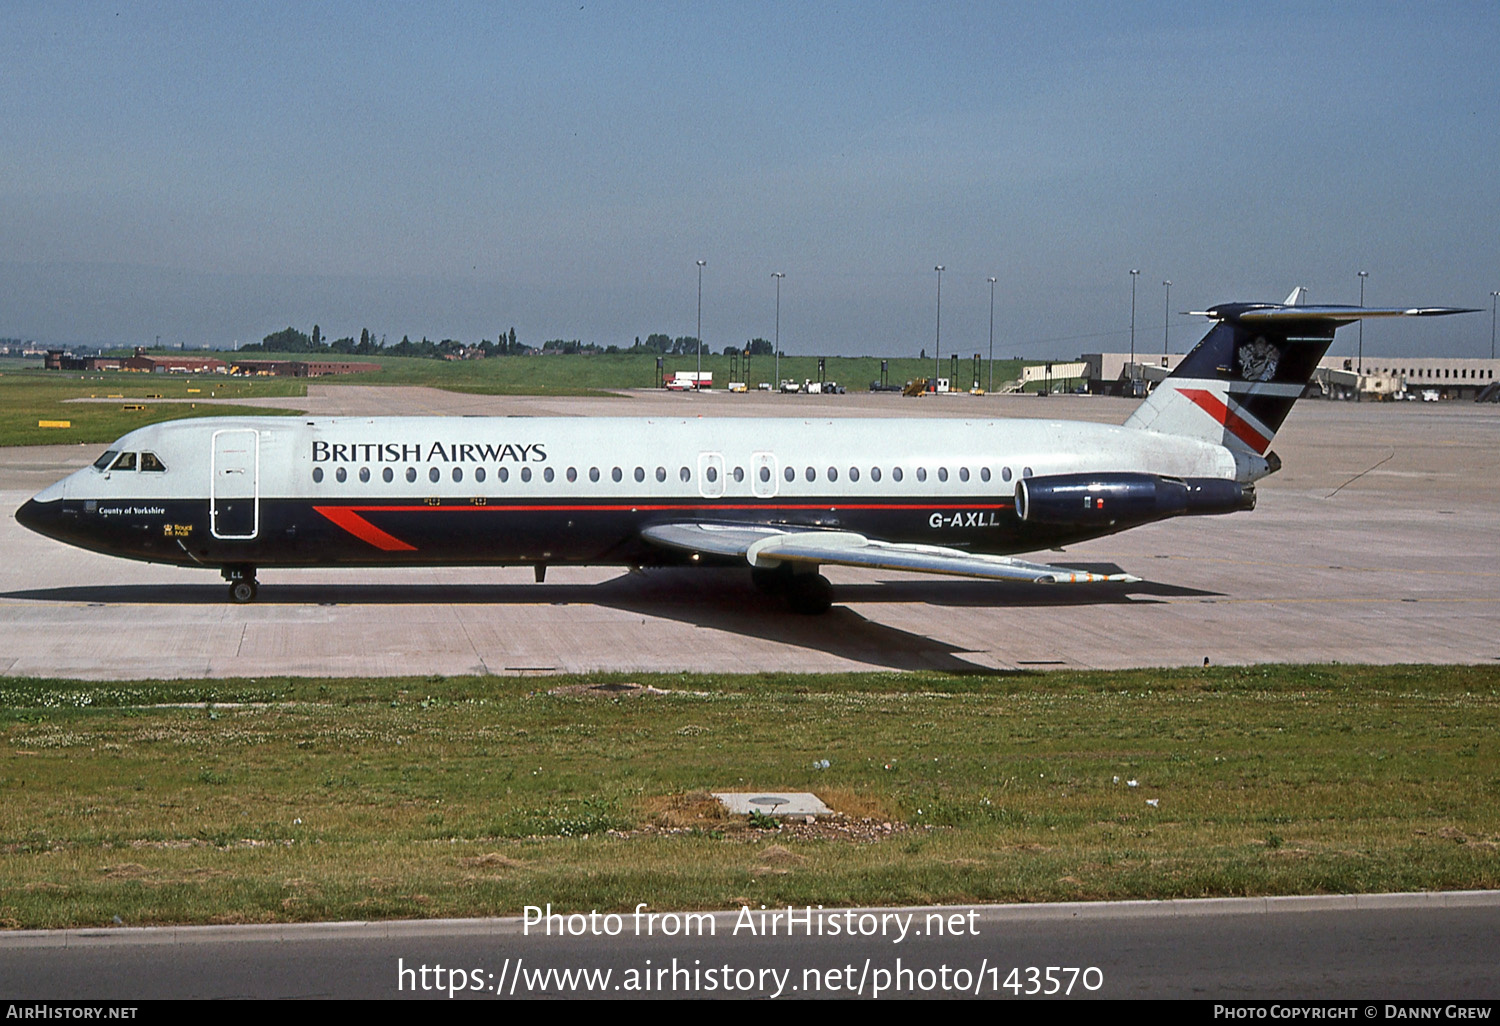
[0,370,306,446]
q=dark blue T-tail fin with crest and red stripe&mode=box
[1125,297,1475,477]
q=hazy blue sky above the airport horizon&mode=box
[0,0,1500,356]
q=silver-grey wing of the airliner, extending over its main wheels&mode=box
[641,524,1140,584]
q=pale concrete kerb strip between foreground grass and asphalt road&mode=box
[0,891,1500,950]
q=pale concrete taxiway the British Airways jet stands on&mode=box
[0,386,1500,678]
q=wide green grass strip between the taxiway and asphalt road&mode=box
[0,666,1500,927]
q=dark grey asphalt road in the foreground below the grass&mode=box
[0,893,1500,996]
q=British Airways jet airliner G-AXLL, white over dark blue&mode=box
[17,287,1475,614]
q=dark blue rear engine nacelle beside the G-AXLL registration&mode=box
[1016,474,1256,527]
